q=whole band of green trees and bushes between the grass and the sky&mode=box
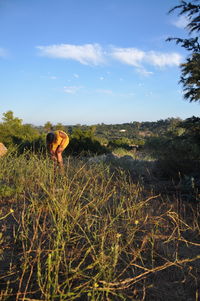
[0,111,200,177]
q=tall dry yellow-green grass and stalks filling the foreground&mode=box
[0,153,200,301]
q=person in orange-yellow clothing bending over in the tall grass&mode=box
[46,130,69,172]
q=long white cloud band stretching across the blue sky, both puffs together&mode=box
[36,44,182,71]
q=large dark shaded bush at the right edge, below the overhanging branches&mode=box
[145,116,200,176]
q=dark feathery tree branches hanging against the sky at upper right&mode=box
[167,0,200,102]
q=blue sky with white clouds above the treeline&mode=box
[0,0,200,125]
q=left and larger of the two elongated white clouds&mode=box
[36,44,104,65]
